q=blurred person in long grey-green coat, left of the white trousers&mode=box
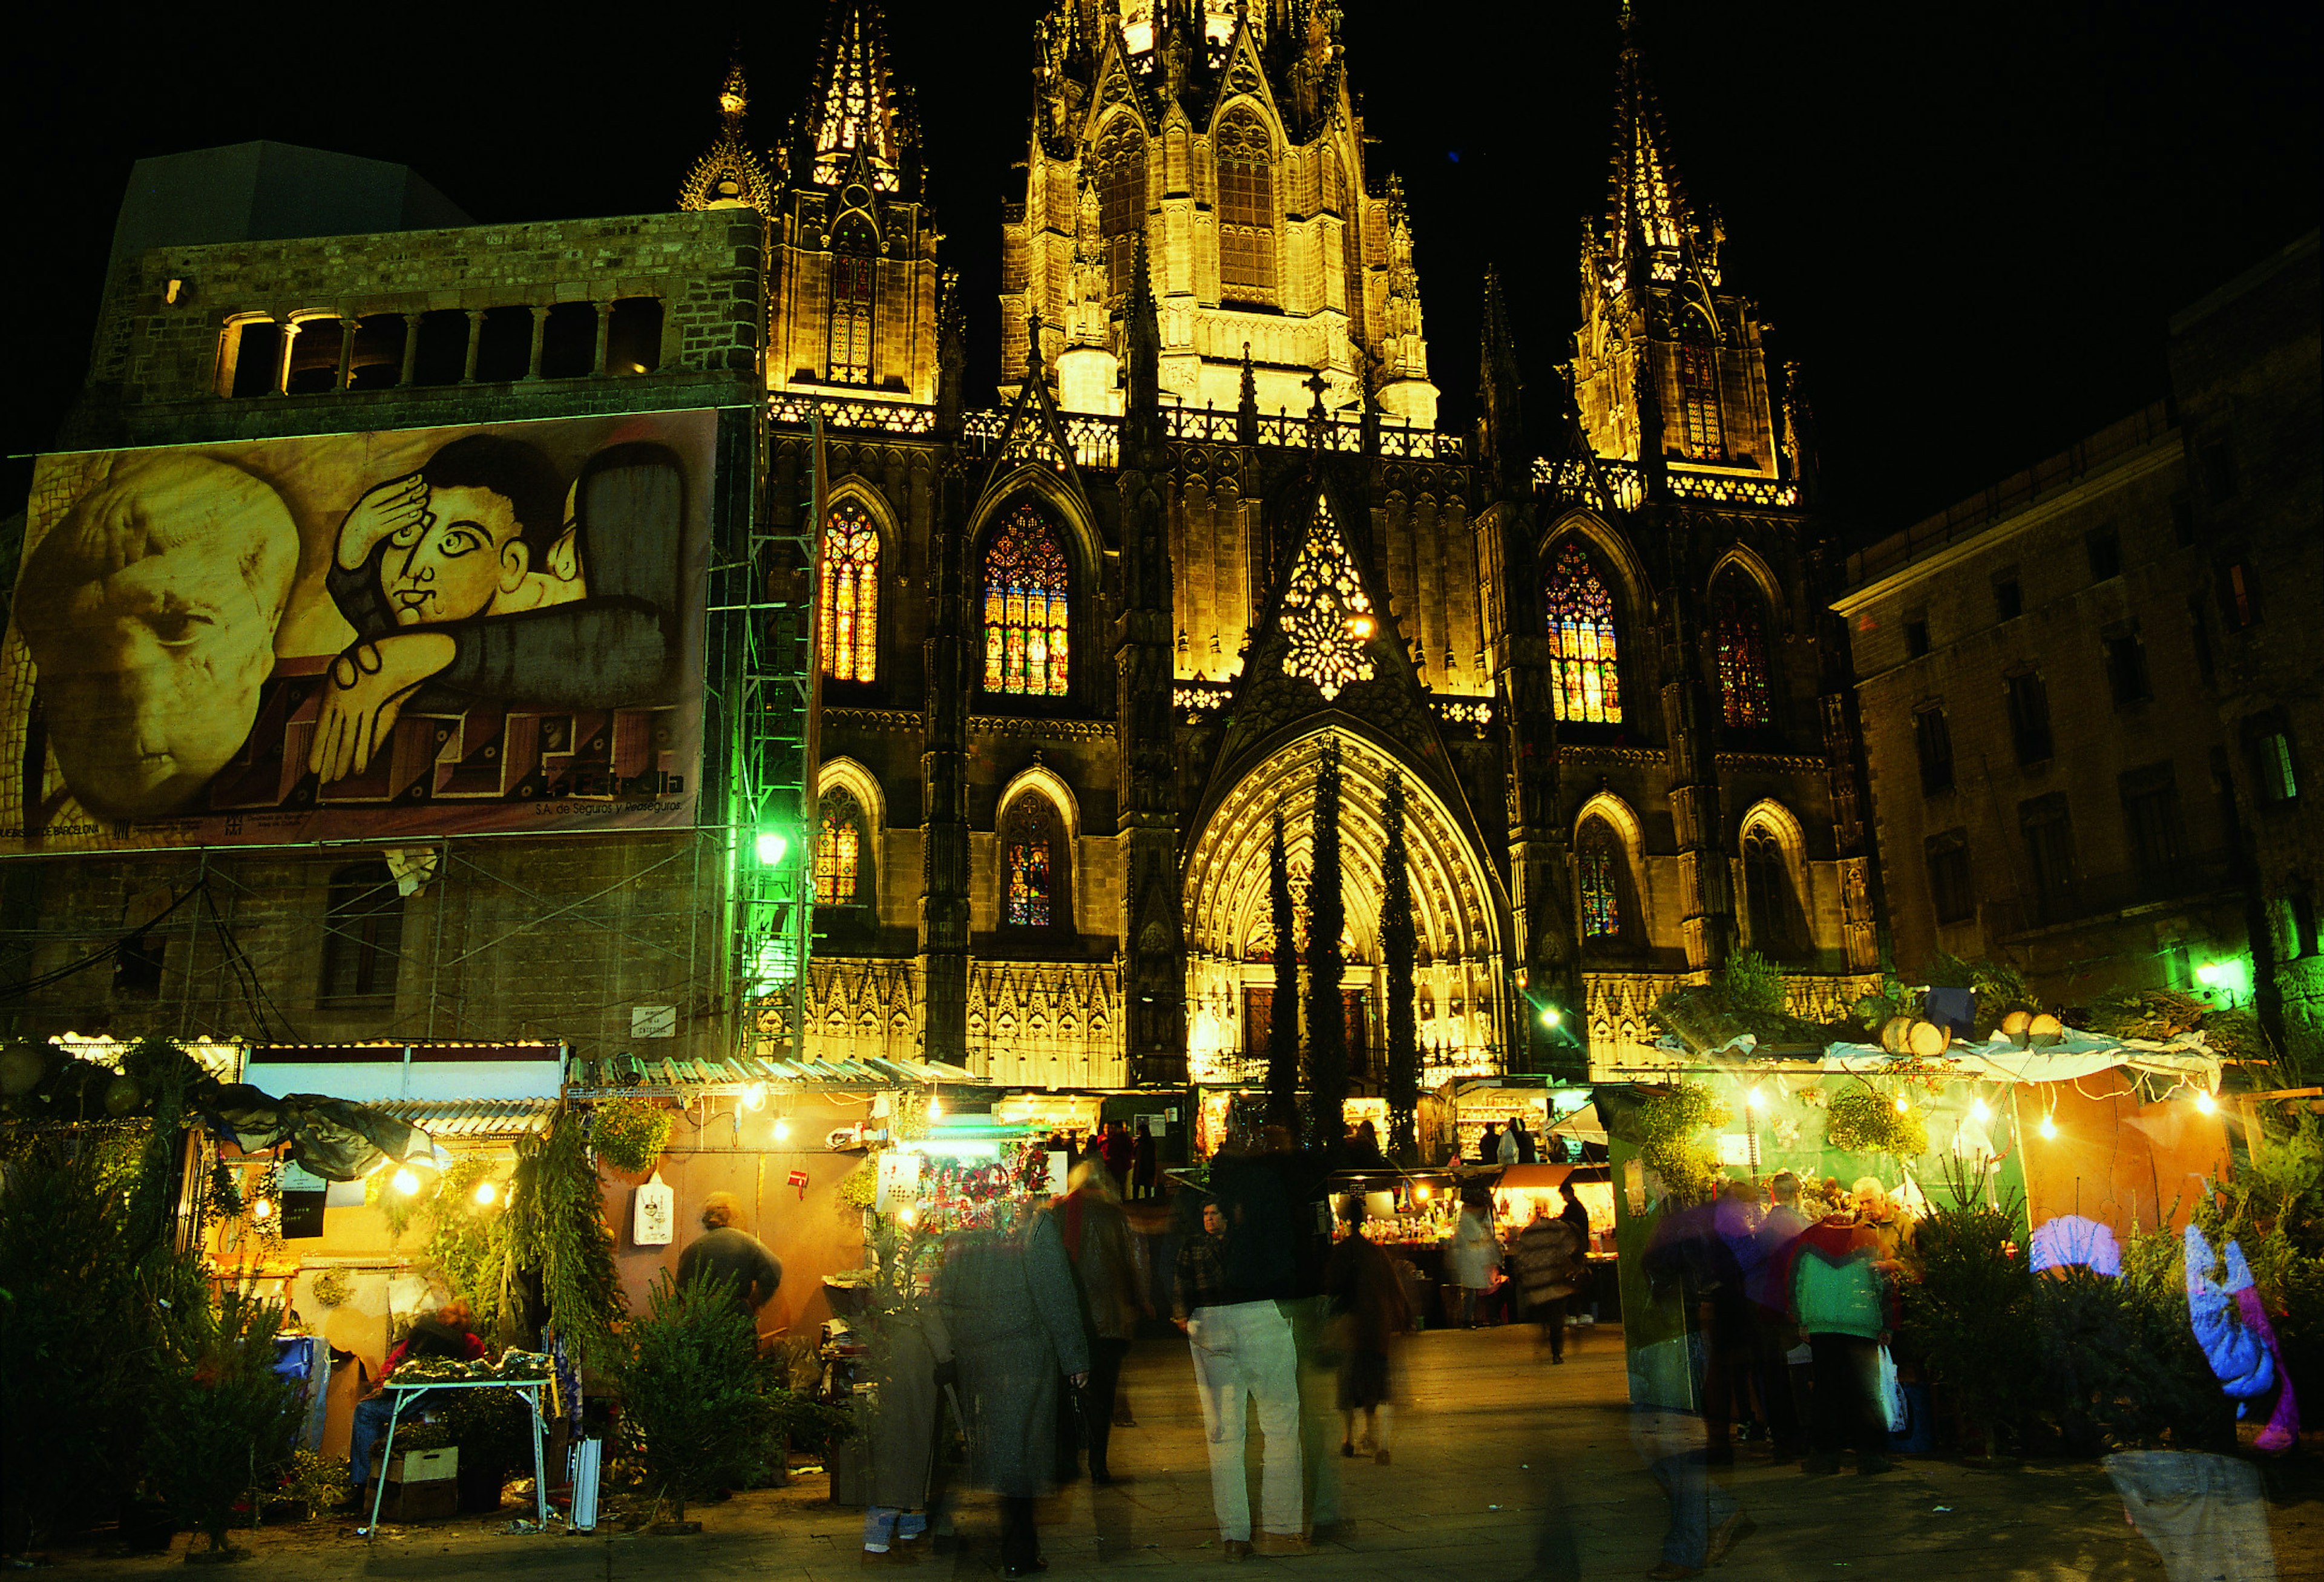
[937,1199,1090,1577]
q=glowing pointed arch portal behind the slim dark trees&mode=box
[1185,725,1506,1083]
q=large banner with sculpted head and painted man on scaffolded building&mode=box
[0,411,718,855]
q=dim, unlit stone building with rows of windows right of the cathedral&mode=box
[1834,235,2324,1055]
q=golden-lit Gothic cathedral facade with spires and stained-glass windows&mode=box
[681,0,1878,1092]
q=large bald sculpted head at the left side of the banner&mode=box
[16,455,298,818]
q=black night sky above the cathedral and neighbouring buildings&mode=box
[5,0,2319,537]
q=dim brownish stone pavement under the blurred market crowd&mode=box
[36,1329,2324,1582]
